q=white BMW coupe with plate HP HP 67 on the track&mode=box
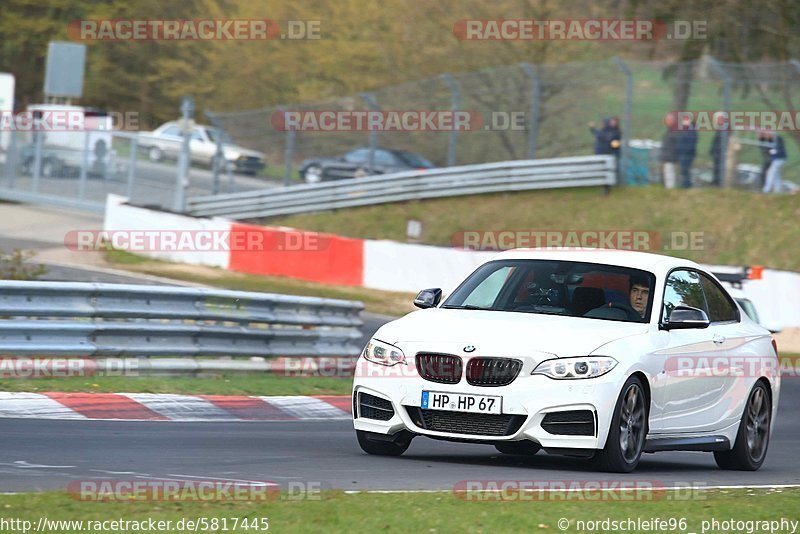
[352,249,780,472]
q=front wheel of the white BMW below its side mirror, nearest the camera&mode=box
[595,376,649,473]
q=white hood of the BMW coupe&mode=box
[375,308,649,357]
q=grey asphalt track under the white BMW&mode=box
[0,378,800,492]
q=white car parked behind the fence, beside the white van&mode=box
[139,121,266,175]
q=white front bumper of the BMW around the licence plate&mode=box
[353,359,624,449]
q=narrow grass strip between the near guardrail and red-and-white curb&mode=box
[0,373,353,395]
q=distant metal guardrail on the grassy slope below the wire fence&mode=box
[188,156,616,219]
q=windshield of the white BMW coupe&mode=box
[442,260,655,322]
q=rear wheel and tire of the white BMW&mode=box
[714,381,772,471]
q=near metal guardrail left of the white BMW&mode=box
[0,281,363,357]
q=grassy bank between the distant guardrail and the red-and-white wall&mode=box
[263,186,800,271]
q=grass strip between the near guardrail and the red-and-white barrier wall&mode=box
[105,250,415,316]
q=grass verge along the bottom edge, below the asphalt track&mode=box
[0,490,800,533]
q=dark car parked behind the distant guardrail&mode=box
[300,148,433,183]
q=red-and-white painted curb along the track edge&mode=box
[0,392,351,421]
